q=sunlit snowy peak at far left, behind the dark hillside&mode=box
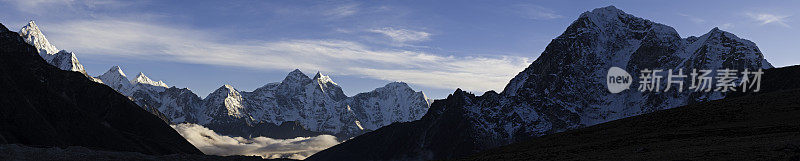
[19,21,86,74]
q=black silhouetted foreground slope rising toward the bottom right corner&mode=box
[461,66,800,160]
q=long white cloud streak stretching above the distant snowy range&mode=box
[48,19,532,91]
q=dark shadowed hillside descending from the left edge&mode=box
[0,22,202,155]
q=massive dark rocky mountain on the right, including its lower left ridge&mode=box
[308,6,772,160]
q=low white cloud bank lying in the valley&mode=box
[170,123,340,159]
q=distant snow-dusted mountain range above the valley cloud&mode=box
[97,66,429,139]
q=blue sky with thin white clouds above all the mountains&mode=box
[0,0,800,98]
